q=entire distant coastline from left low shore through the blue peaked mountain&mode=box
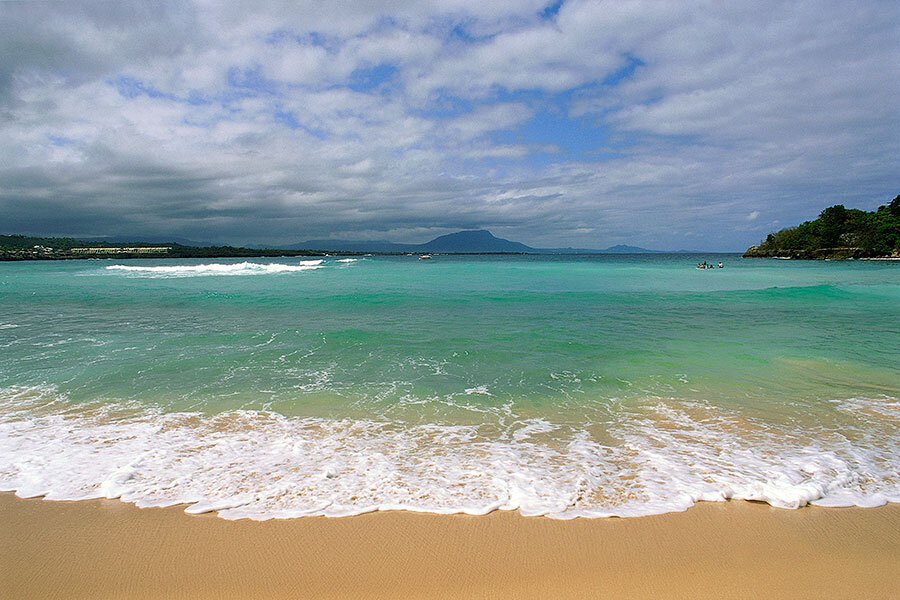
[0,229,676,261]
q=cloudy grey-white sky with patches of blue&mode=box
[0,0,900,251]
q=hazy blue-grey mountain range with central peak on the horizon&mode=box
[286,229,661,254]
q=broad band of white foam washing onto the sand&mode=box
[0,387,900,519]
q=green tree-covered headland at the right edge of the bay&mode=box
[744,195,900,260]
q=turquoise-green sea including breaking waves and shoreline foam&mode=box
[0,255,900,518]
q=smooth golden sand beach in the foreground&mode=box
[0,493,900,599]
